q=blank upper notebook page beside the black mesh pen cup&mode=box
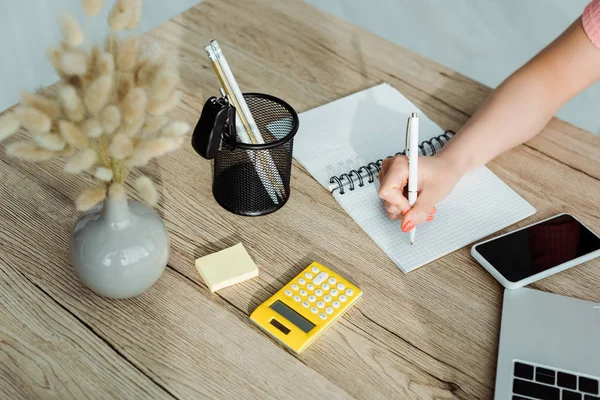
[294,83,444,187]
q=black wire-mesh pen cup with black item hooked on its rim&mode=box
[192,93,298,216]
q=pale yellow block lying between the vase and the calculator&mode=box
[196,243,258,292]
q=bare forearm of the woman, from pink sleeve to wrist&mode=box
[440,20,600,173]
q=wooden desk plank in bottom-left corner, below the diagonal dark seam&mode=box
[0,255,172,400]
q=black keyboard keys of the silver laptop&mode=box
[512,361,600,400]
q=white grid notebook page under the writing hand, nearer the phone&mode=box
[334,167,535,272]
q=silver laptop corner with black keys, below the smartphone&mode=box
[495,288,600,400]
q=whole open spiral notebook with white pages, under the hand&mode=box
[294,83,535,272]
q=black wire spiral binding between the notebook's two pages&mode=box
[329,130,456,194]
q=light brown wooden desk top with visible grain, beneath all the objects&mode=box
[0,0,600,399]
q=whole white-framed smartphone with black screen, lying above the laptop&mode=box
[471,214,600,289]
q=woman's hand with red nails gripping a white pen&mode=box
[379,153,462,232]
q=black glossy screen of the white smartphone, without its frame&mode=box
[476,215,600,282]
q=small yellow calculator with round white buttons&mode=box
[250,262,362,354]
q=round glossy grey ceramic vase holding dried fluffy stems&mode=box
[71,199,169,299]
